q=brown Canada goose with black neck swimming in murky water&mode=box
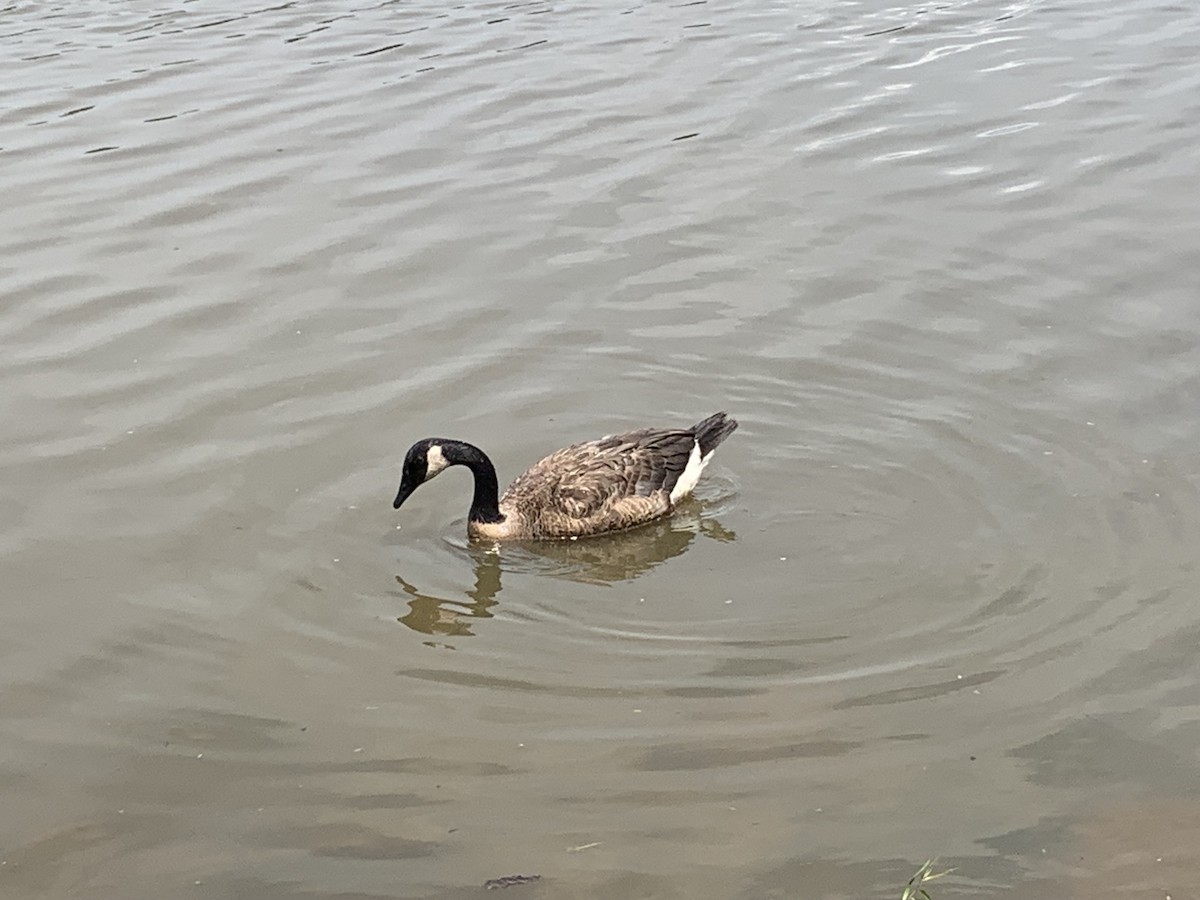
[392,413,738,540]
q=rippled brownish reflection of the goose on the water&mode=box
[396,506,737,637]
